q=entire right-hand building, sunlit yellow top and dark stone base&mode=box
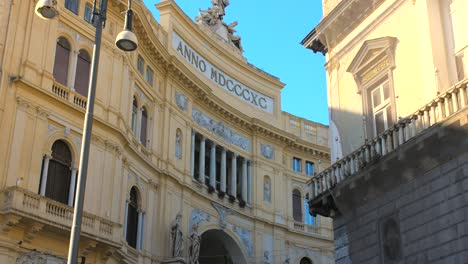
[302,0,468,264]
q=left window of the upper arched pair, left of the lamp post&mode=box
[53,37,70,86]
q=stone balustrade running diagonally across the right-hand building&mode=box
[310,79,468,199]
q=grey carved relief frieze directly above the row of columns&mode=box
[192,108,251,152]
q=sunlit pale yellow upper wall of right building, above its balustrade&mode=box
[302,0,468,161]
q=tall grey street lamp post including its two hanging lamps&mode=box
[35,0,138,264]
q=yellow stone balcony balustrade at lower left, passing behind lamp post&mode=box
[0,187,121,246]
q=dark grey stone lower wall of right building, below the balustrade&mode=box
[332,109,468,264]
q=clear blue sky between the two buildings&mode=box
[144,0,328,124]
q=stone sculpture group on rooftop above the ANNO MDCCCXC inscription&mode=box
[195,0,242,51]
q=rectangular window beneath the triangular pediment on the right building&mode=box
[371,80,393,136]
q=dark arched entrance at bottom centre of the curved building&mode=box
[199,230,247,264]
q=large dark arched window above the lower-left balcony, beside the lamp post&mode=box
[45,140,72,204]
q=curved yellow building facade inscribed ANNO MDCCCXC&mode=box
[0,0,333,263]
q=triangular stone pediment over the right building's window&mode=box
[347,37,397,74]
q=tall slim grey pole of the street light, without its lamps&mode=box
[67,0,107,264]
